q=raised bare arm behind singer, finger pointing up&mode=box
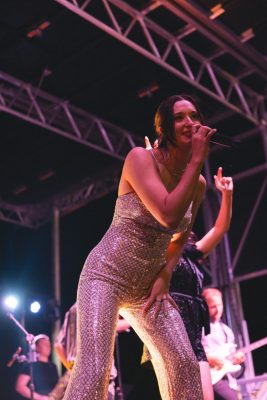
[196,167,233,257]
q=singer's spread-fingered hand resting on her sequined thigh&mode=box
[143,268,178,318]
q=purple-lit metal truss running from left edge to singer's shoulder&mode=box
[0,72,142,160]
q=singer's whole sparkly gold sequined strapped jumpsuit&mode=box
[64,192,203,400]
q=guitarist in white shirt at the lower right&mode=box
[202,288,245,400]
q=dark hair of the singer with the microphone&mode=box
[154,95,204,147]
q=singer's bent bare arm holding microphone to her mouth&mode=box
[119,126,214,229]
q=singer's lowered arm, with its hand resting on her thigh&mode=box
[144,176,206,315]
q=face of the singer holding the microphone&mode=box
[173,100,200,146]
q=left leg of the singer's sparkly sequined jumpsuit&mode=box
[64,276,119,400]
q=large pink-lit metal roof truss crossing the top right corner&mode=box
[55,0,267,125]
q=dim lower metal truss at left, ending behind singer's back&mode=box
[0,168,120,229]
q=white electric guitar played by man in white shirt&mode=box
[210,337,267,385]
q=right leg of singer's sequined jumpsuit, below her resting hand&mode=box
[120,301,203,400]
